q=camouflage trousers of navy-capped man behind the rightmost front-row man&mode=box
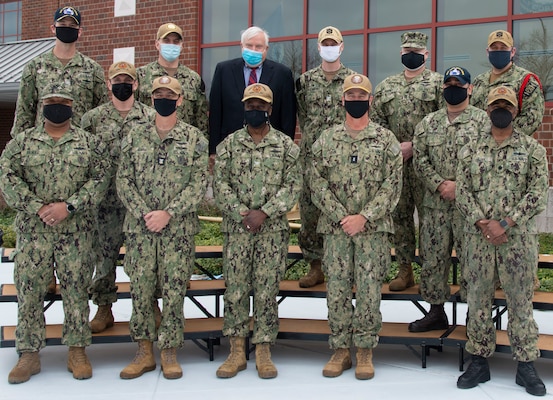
[420,202,466,304]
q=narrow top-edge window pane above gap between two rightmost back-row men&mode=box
[438,0,507,21]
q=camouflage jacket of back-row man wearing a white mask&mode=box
[296,65,355,155]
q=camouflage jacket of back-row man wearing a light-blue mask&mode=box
[135,61,207,133]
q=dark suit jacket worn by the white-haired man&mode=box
[209,58,296,154]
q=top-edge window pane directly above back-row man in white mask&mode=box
[306,0,362,33]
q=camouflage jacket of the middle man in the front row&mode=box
[213,127,302,233]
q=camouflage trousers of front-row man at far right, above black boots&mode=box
[463,232,540,362]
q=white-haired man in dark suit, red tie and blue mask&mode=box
[209,26,296,159]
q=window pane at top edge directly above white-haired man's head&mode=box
[253,0,303,37]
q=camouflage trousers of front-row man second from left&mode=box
[124,233,195,349]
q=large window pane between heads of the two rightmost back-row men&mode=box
[436,23,506,78]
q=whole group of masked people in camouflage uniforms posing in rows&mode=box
[0,7,548,395]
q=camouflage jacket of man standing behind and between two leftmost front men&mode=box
[81,101,156,209]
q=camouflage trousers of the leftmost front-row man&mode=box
[14,232,94,353]
